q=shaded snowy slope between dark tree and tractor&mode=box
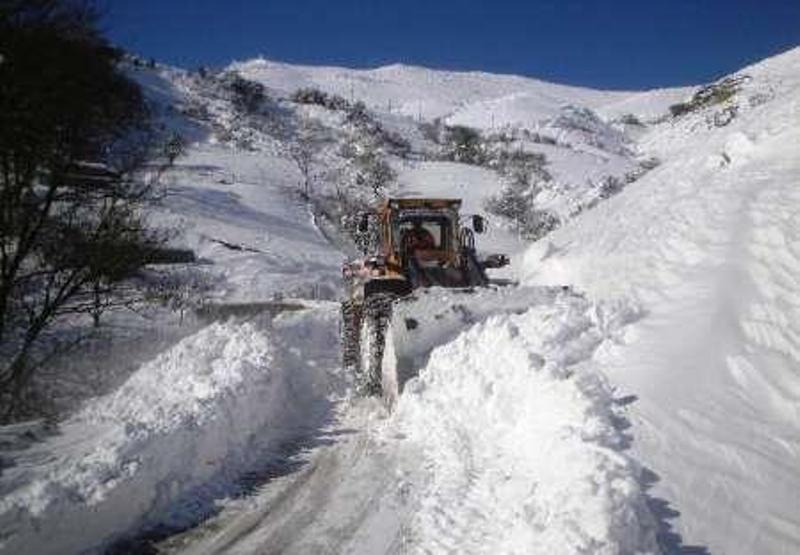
[159,145,343,302]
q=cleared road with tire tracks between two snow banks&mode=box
[166,402,422,555]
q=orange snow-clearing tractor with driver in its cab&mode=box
[342,198,508,403]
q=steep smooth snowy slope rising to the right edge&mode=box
[526,44,800,553]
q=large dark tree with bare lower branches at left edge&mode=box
[0,0,158,419]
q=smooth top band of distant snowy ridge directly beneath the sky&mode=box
[231,59,692,128]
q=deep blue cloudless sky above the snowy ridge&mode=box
[100,0,800,89]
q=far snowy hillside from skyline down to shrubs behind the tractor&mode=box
[231,55,693,223]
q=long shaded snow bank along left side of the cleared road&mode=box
[0,309,337,554]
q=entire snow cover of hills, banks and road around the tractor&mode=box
[0,49,800,554]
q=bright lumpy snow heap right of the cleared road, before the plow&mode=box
[396,296,658,554]
